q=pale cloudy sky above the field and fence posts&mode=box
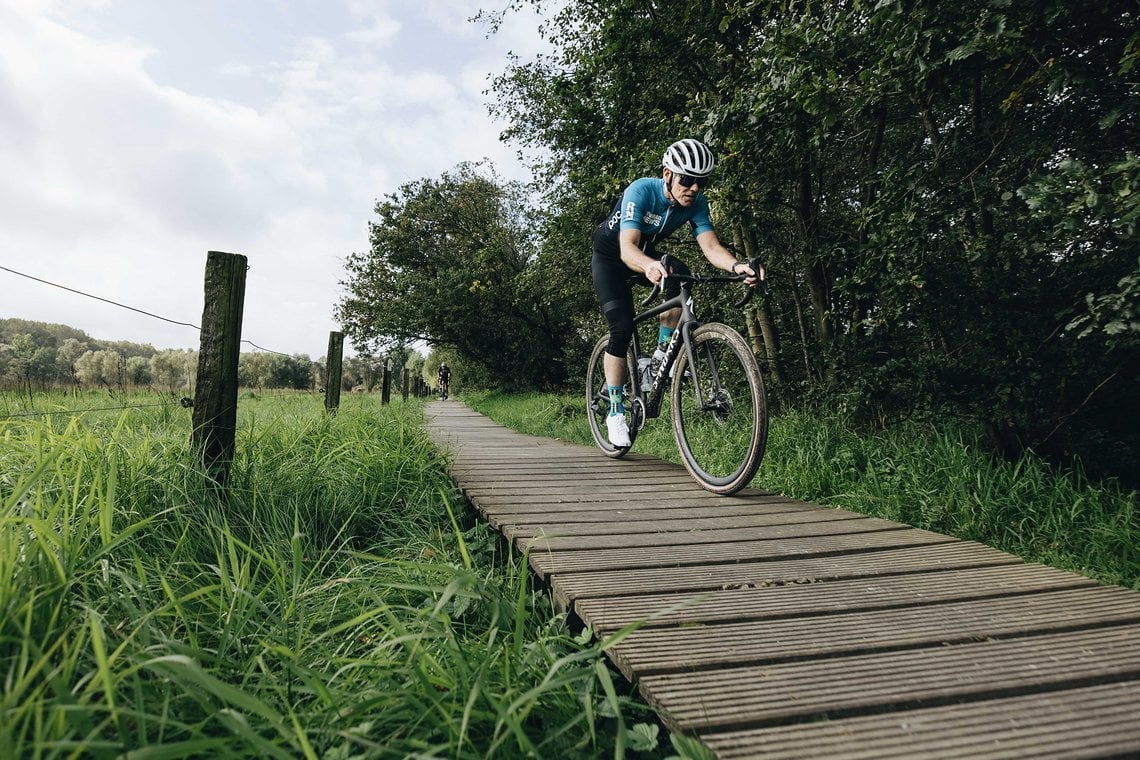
[0,0,542,359]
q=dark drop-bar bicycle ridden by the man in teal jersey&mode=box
[586,255,768,496]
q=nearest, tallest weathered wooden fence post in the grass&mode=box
[190,251,249,487]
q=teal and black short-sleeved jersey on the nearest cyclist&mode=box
[594,177,714,255]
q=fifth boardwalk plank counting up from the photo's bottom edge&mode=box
[551,541,1021,610]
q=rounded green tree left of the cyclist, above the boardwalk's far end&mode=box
[337,164,571,387]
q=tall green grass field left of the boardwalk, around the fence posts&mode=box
[0,394,703,760]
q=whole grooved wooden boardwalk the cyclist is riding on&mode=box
[428,401,1140,759]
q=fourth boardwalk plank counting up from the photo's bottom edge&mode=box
[575,564,1098,636]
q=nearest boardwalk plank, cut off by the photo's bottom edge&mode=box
[701,681,1140,760]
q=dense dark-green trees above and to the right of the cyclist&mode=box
[483,0,1140,482]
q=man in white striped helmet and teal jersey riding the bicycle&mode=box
[591,139,764,447]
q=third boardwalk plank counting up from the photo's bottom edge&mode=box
[611,586,1140,678]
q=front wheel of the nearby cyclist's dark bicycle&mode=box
[670,322,768,495]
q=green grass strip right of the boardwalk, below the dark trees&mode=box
[464,393,1140,589]
